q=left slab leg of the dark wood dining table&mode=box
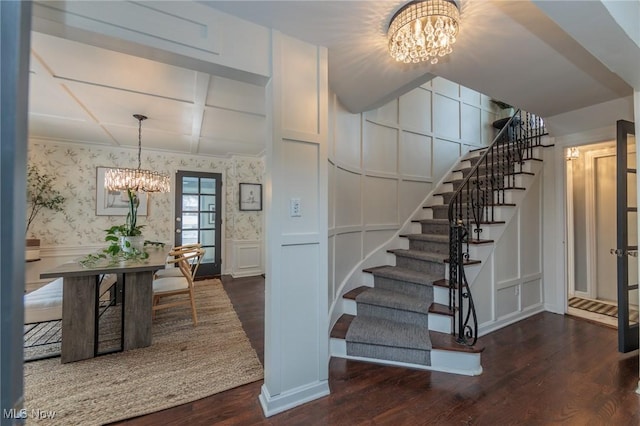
[60,275,97,363]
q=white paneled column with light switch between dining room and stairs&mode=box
[259,32,329,416]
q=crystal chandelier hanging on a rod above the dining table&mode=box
[104,114,171,192]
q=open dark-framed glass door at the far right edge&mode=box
[612,120,638,352]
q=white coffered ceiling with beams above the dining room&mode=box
[29,33,266,155]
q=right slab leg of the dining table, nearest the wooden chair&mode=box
[123,271,153,351]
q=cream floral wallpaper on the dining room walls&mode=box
[25,142,264,247]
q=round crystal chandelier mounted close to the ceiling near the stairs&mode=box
[387,0,460,64]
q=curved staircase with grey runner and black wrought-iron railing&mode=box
[330,111,545,375]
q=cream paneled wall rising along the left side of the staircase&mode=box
[328,78,498,304]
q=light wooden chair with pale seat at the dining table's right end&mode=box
[152,248,205,326]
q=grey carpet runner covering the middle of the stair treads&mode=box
[344,146,500,366]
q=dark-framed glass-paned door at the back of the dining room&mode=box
[175,171,223,277]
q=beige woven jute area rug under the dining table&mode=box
[24,280,263,425]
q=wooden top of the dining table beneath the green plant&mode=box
[40,246,170,278]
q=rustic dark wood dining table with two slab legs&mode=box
[40,247,169,363]
